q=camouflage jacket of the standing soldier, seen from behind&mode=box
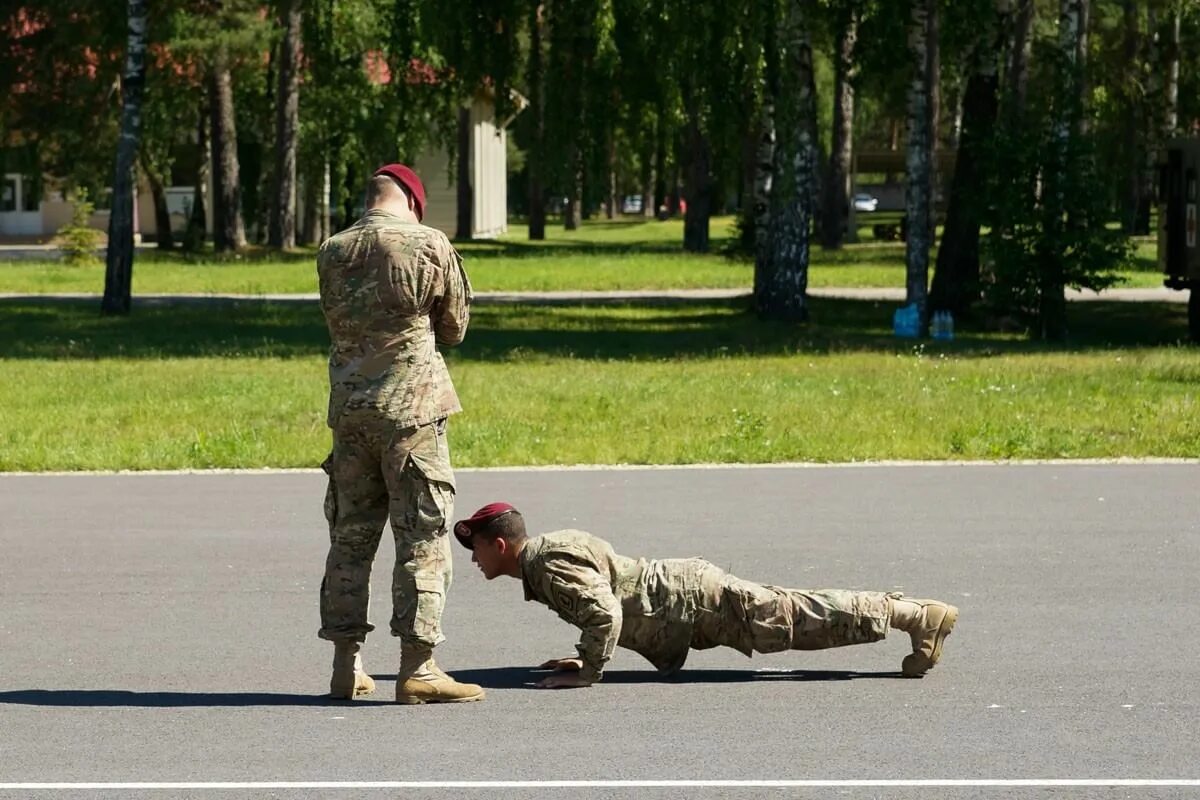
[317,210,472,427]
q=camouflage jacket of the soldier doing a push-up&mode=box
[521,530,707,681]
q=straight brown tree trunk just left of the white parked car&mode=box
[821,2,858,249]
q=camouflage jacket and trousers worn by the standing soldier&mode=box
[317,210,472,646]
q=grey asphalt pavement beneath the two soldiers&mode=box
[0,464,1200,799]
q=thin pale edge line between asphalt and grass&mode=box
[0,457,1200,477]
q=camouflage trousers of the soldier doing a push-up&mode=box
[691,561,899,656]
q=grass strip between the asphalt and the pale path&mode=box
[0,293,1200,470]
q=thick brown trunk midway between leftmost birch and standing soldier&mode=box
[209,47,246,253]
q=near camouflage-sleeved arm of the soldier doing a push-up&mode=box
[547,564,622,685]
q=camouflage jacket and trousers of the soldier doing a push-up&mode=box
[520,530,899,681]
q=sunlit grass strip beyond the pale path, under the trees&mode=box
[0,215,1163,294]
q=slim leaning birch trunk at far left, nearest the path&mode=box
[100,0,146,314]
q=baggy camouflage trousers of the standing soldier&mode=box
[318,419,455,646]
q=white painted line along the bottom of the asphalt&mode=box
[0,778,1200,792]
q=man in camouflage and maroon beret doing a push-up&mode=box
[454,503,959,688]
